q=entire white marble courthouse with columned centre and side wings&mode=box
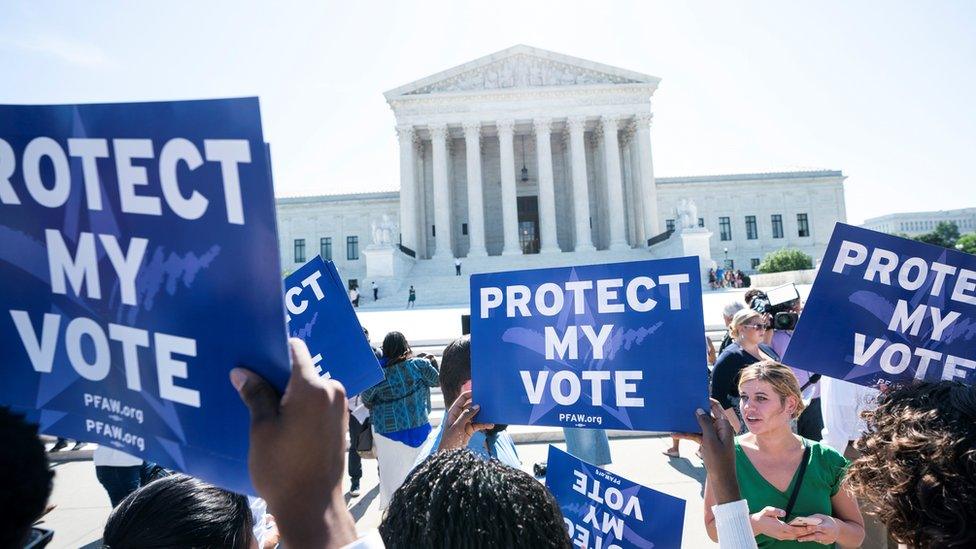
[278,45,846,304]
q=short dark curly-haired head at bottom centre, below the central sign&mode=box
[379,448,570,549]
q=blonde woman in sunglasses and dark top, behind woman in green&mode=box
[711,309,780,433]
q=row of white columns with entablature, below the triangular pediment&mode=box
[397,113,663,259]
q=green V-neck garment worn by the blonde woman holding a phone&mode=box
[735,437,848,549]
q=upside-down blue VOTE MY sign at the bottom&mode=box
[546,445,685,549]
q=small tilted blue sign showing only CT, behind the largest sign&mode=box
[285,256,383,396]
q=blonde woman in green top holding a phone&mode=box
[705,360,864,549]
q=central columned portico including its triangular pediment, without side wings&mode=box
[386,46,663,259]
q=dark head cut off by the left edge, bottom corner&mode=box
[0,407,54,549]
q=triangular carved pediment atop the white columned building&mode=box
[384,45,660,100]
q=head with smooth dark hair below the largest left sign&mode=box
[102,475,257,549]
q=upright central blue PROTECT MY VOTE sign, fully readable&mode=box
[471,257,708,432]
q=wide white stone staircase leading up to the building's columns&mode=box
[359,248,651,311]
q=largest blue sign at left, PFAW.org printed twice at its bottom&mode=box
[0,98,290,493]
